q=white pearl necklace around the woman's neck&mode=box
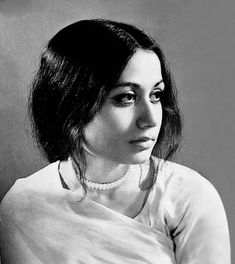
[84,166,132,191]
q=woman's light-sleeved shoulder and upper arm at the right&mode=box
[150,161,230,263]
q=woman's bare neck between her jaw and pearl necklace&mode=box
[85,152,128,183]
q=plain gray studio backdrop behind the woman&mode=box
[0,0,235,262]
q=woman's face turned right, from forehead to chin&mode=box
[85,49,164,164]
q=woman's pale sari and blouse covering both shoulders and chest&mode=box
[0,158,230,264]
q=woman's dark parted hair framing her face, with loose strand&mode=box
[29,19,182,190]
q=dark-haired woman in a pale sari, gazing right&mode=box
[1,19,230,264]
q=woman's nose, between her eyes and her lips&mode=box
[136,101,162,129]
